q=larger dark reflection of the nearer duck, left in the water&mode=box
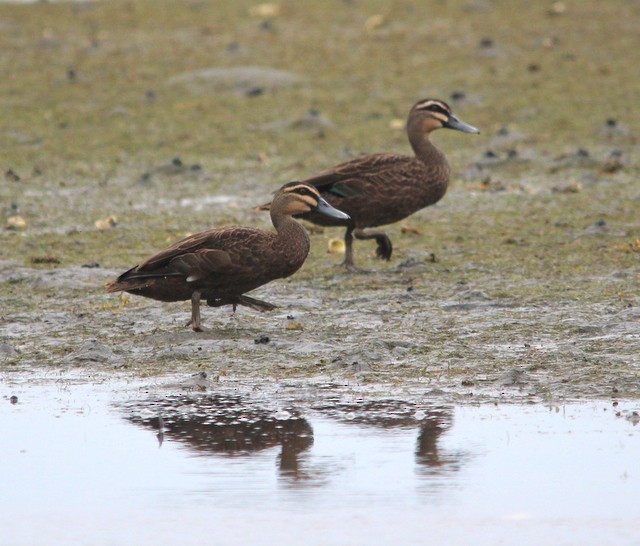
[126,395,313,479]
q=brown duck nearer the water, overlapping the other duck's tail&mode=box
[107,182,349,332]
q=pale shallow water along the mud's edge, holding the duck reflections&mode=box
[0,375,640,545]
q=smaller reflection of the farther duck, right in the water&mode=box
[313,400,468,476]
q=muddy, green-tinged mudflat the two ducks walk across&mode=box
[0,0,640,402]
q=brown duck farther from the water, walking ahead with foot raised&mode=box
[259,99,480,271]
